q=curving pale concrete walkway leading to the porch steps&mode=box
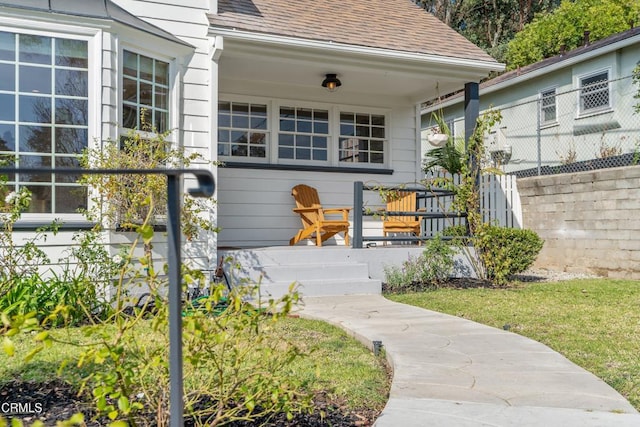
[300,295,640,427]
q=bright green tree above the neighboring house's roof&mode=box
[505,0,640,69]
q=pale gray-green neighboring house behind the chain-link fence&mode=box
[421,27,640,176]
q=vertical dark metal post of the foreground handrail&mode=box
[167,175,184,427]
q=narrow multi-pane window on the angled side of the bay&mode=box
[122,50,169,132]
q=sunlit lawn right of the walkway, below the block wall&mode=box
[387,279,640,410]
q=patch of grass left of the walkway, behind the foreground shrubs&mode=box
[0,318,389,411]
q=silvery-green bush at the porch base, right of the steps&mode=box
[384,236,455,293]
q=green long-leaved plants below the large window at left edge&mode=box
[0,189,118,326]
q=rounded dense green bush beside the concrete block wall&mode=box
[474,224,544,285]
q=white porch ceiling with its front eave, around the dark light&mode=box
[217,34,501,104]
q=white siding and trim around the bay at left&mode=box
[0,0,216,270]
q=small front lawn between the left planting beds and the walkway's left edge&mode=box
[0,317,389,425]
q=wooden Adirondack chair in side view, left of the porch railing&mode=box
[289,184,351,246]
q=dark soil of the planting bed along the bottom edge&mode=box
[0,380,379,427]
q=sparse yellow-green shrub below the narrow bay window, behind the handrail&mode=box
[80,119,215,240]
